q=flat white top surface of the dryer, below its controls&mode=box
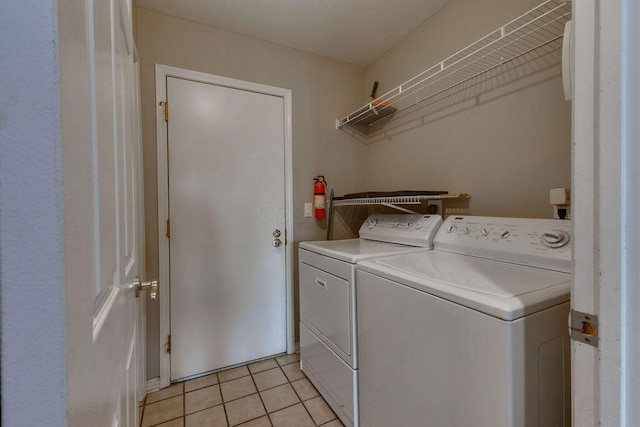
[300,239,427,264]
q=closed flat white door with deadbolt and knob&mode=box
[167,77,287,380]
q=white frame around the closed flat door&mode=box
[156,64,295,388]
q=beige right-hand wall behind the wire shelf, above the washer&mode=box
[362,0,571,218]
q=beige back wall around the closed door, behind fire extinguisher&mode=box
[137,8,365,378]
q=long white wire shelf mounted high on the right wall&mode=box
[336,0,571,128]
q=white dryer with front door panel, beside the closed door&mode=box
[299,214,442,427]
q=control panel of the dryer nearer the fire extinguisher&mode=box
[359,214,442,248]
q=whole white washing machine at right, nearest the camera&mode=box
[356,216,571,427]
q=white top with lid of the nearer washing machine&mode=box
[358,251,571,320]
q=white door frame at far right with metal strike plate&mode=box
[571,0,640,427]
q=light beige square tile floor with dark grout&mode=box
[140,354,343,427]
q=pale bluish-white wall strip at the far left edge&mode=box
[0,0,66,426]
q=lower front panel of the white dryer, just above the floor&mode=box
[300,323,358,427]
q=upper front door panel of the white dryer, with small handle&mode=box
[300,263,353,362]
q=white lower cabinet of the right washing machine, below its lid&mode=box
[356,271,570,427]
